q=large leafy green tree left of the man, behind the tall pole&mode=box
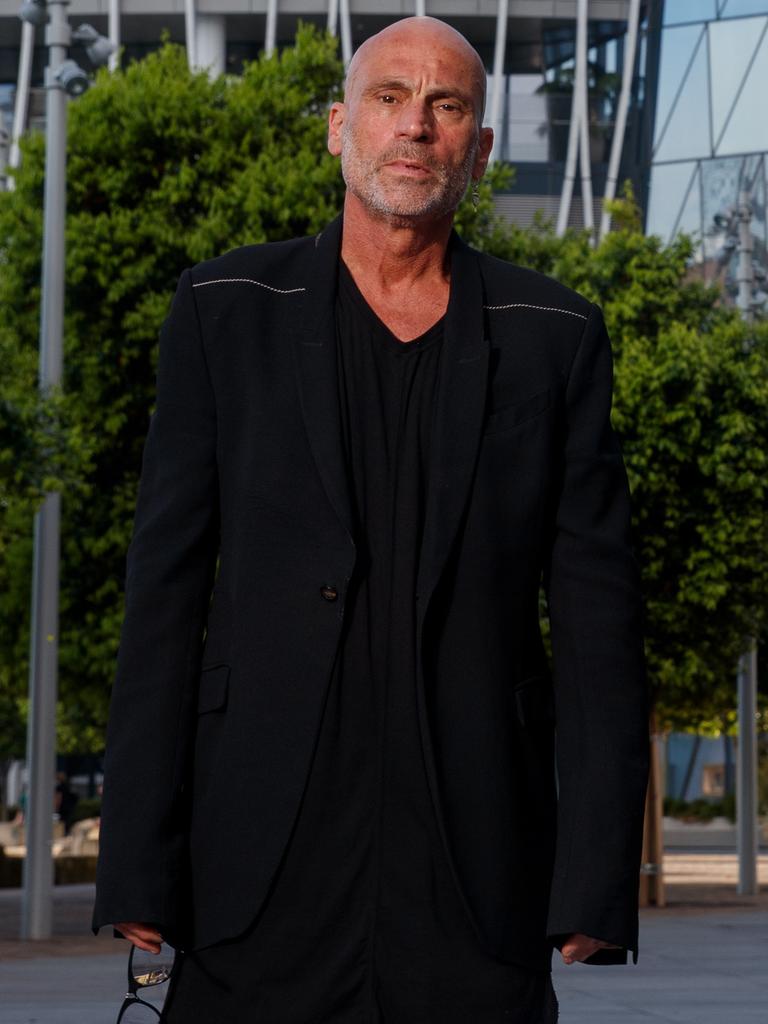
[0,28,343,754]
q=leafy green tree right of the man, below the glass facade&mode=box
[475,190,768,731]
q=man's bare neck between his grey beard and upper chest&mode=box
[341,193,454,293]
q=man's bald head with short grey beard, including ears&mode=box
[329,28,493,222]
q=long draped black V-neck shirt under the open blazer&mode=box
[162,263,556,1024]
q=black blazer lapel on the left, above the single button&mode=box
[291,215,354,540]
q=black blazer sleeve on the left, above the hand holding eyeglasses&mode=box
[91,270,219,934]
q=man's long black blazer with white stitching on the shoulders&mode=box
[93,218,648,967]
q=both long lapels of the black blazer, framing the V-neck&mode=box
[293,215,489,616]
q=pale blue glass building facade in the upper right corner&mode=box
[646,0,768,306]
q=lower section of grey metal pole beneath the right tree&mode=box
[736,640,758,896]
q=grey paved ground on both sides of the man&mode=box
[0,853,768,1024]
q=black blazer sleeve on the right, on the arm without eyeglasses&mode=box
[545,305,649,964]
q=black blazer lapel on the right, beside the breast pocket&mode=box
[417,232,490,625]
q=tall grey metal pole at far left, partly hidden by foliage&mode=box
[22,0,70,939]
